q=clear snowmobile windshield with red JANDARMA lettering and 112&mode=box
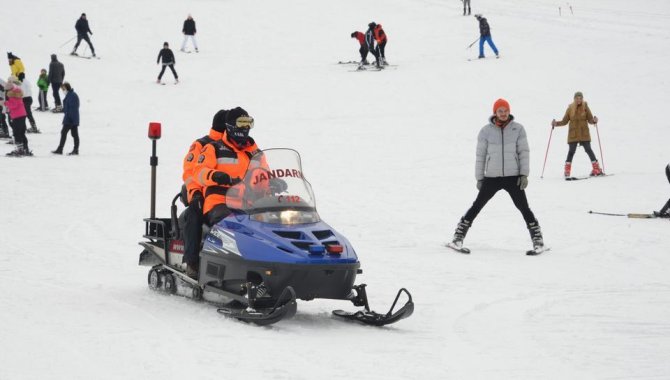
[226,149,320,224]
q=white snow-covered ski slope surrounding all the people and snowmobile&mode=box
[0,0,670,380]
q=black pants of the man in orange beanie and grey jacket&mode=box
[463,176,536,224]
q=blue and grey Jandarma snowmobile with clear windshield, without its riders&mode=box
[139,149,414,326]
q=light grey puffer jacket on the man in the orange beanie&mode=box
[475,115,530,181]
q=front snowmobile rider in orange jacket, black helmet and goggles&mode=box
[193,107,259,226]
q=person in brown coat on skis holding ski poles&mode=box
[551,91,605,178]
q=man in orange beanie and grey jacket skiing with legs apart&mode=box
[447,99,544,255]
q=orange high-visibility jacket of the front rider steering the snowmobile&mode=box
[193,133,258,214]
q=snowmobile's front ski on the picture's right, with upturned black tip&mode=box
[333,284,414,326]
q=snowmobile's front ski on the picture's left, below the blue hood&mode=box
[216,286,298,326]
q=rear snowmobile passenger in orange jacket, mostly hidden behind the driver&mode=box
[182,110,228,277]
